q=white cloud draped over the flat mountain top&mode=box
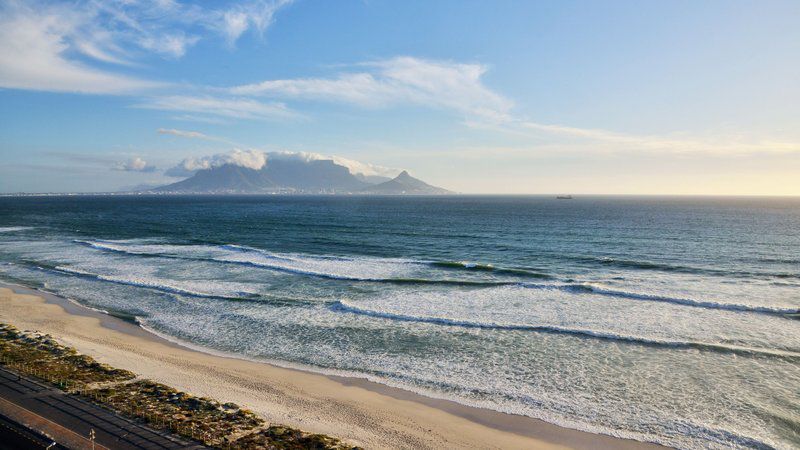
[164,149,401,177]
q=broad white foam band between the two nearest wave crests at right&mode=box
[337,285,800,358]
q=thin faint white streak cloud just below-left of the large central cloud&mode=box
[135,95,301,120]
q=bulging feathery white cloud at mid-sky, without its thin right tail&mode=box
[231,57,513,121]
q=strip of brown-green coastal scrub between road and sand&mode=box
[0,323,356,450]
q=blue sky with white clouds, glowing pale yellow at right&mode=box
[0,0,800,195]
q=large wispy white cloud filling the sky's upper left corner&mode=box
[0,0,290,94]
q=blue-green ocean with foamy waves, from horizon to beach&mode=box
[0,196,800,449]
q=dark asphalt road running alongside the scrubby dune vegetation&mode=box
[0,367,204,450]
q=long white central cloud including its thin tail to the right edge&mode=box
[230,57,800,155]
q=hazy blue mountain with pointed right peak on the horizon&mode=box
[147,159,451,195]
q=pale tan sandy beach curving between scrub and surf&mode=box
[0,282,664,449]
